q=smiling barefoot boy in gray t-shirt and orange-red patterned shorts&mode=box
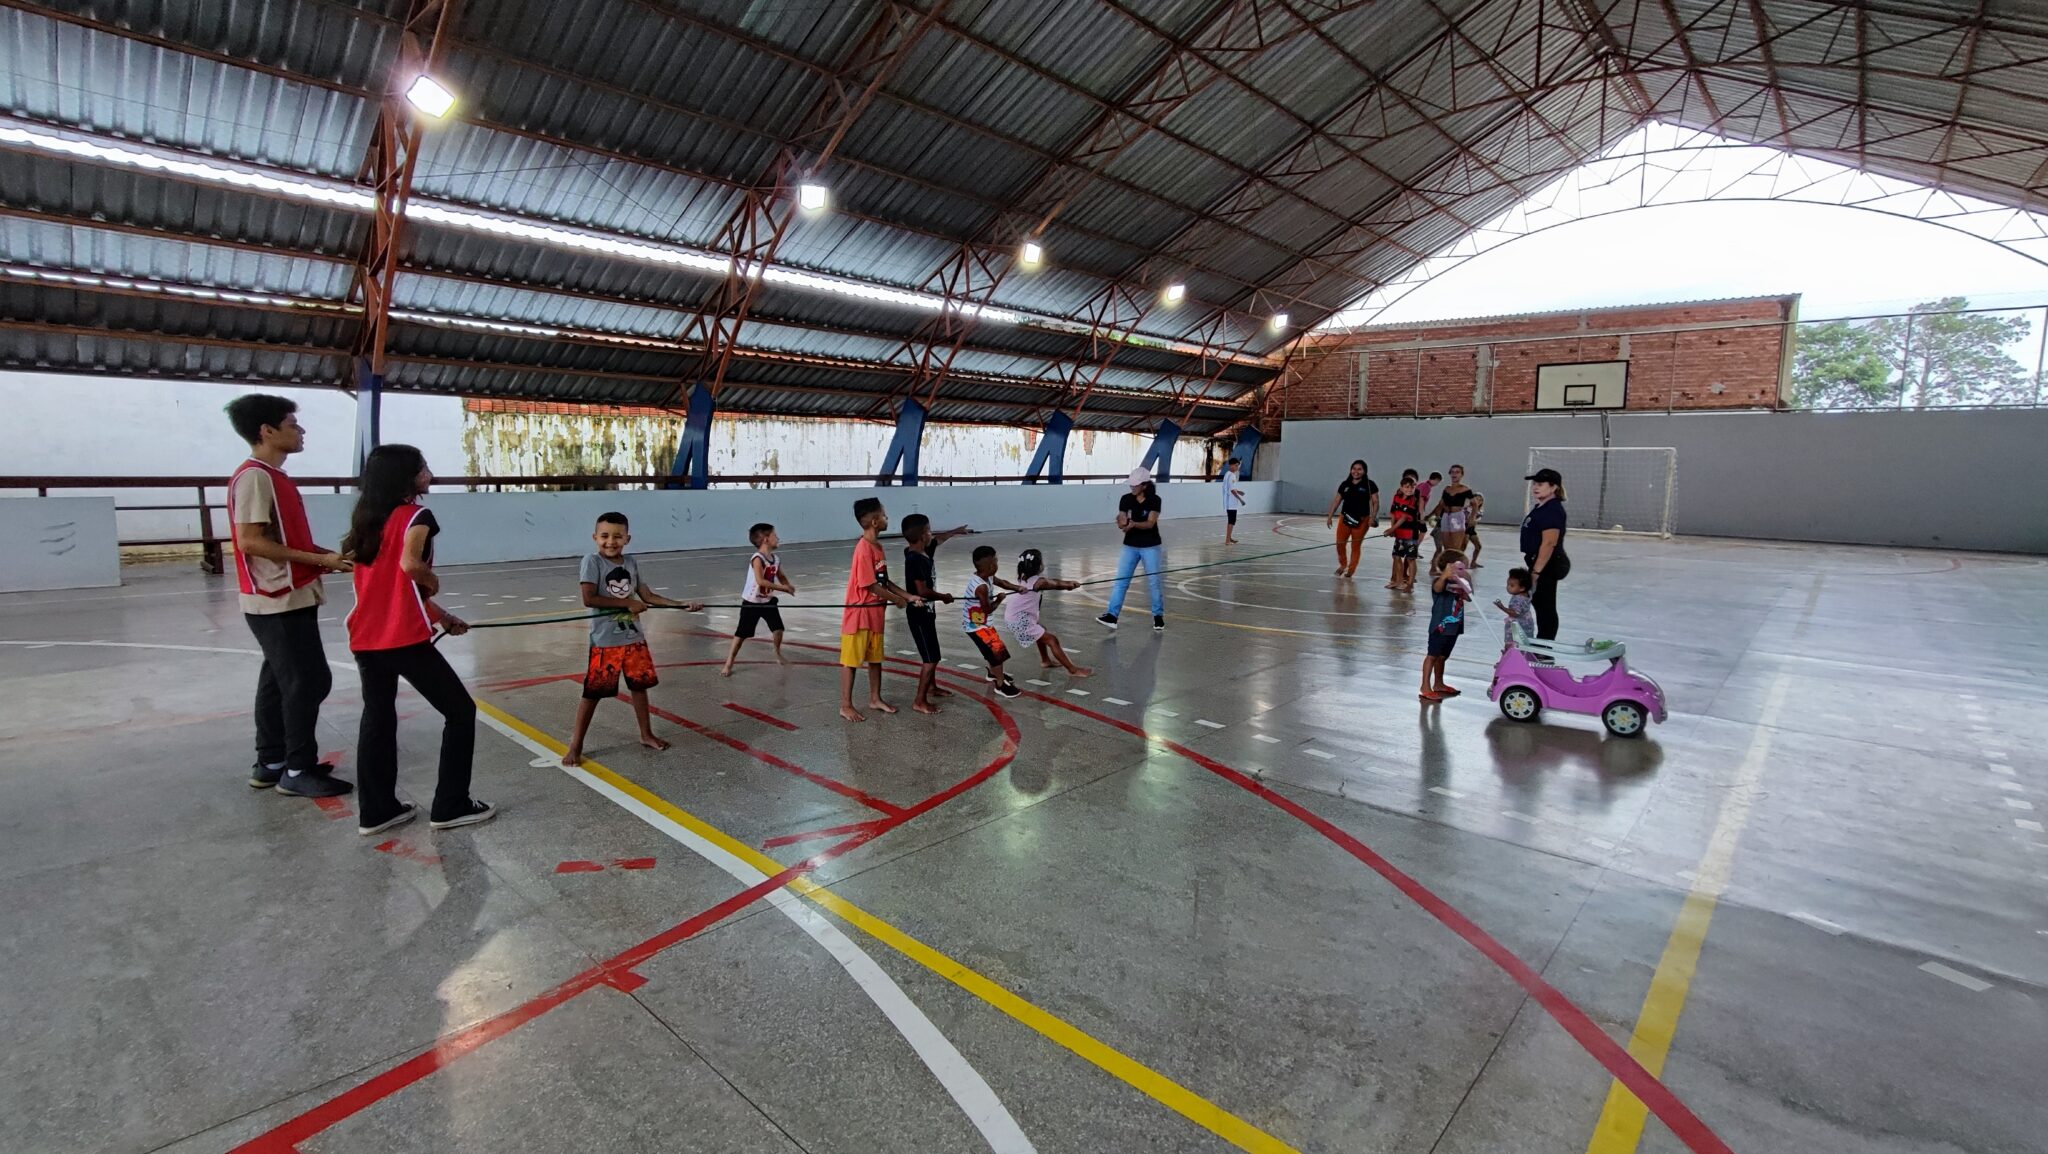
[561,512,705,765]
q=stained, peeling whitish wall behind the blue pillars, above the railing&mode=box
[463,402,1204,478]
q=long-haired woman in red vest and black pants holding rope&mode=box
[342,445,498,834]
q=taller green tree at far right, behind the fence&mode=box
[1870,297,2034,408]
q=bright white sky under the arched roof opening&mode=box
[1327,123,2048,328]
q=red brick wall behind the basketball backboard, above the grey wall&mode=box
[1286,297,1798,420]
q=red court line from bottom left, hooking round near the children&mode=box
[227,660,1022,1154]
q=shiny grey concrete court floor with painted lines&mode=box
[0,508,2048,1154]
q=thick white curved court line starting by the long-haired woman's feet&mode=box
[477,711,1036,1154]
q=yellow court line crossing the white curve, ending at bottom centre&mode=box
[477,701,1300,1154]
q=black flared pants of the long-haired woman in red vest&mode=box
[356,642,477,826]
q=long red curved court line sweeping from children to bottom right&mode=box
[720,642,1733,1154]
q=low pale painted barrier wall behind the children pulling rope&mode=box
[305,482,1280,566]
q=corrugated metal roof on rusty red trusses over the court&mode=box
[0,0,2048,428]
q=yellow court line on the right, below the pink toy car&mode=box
[1585,672,1788,1154]
